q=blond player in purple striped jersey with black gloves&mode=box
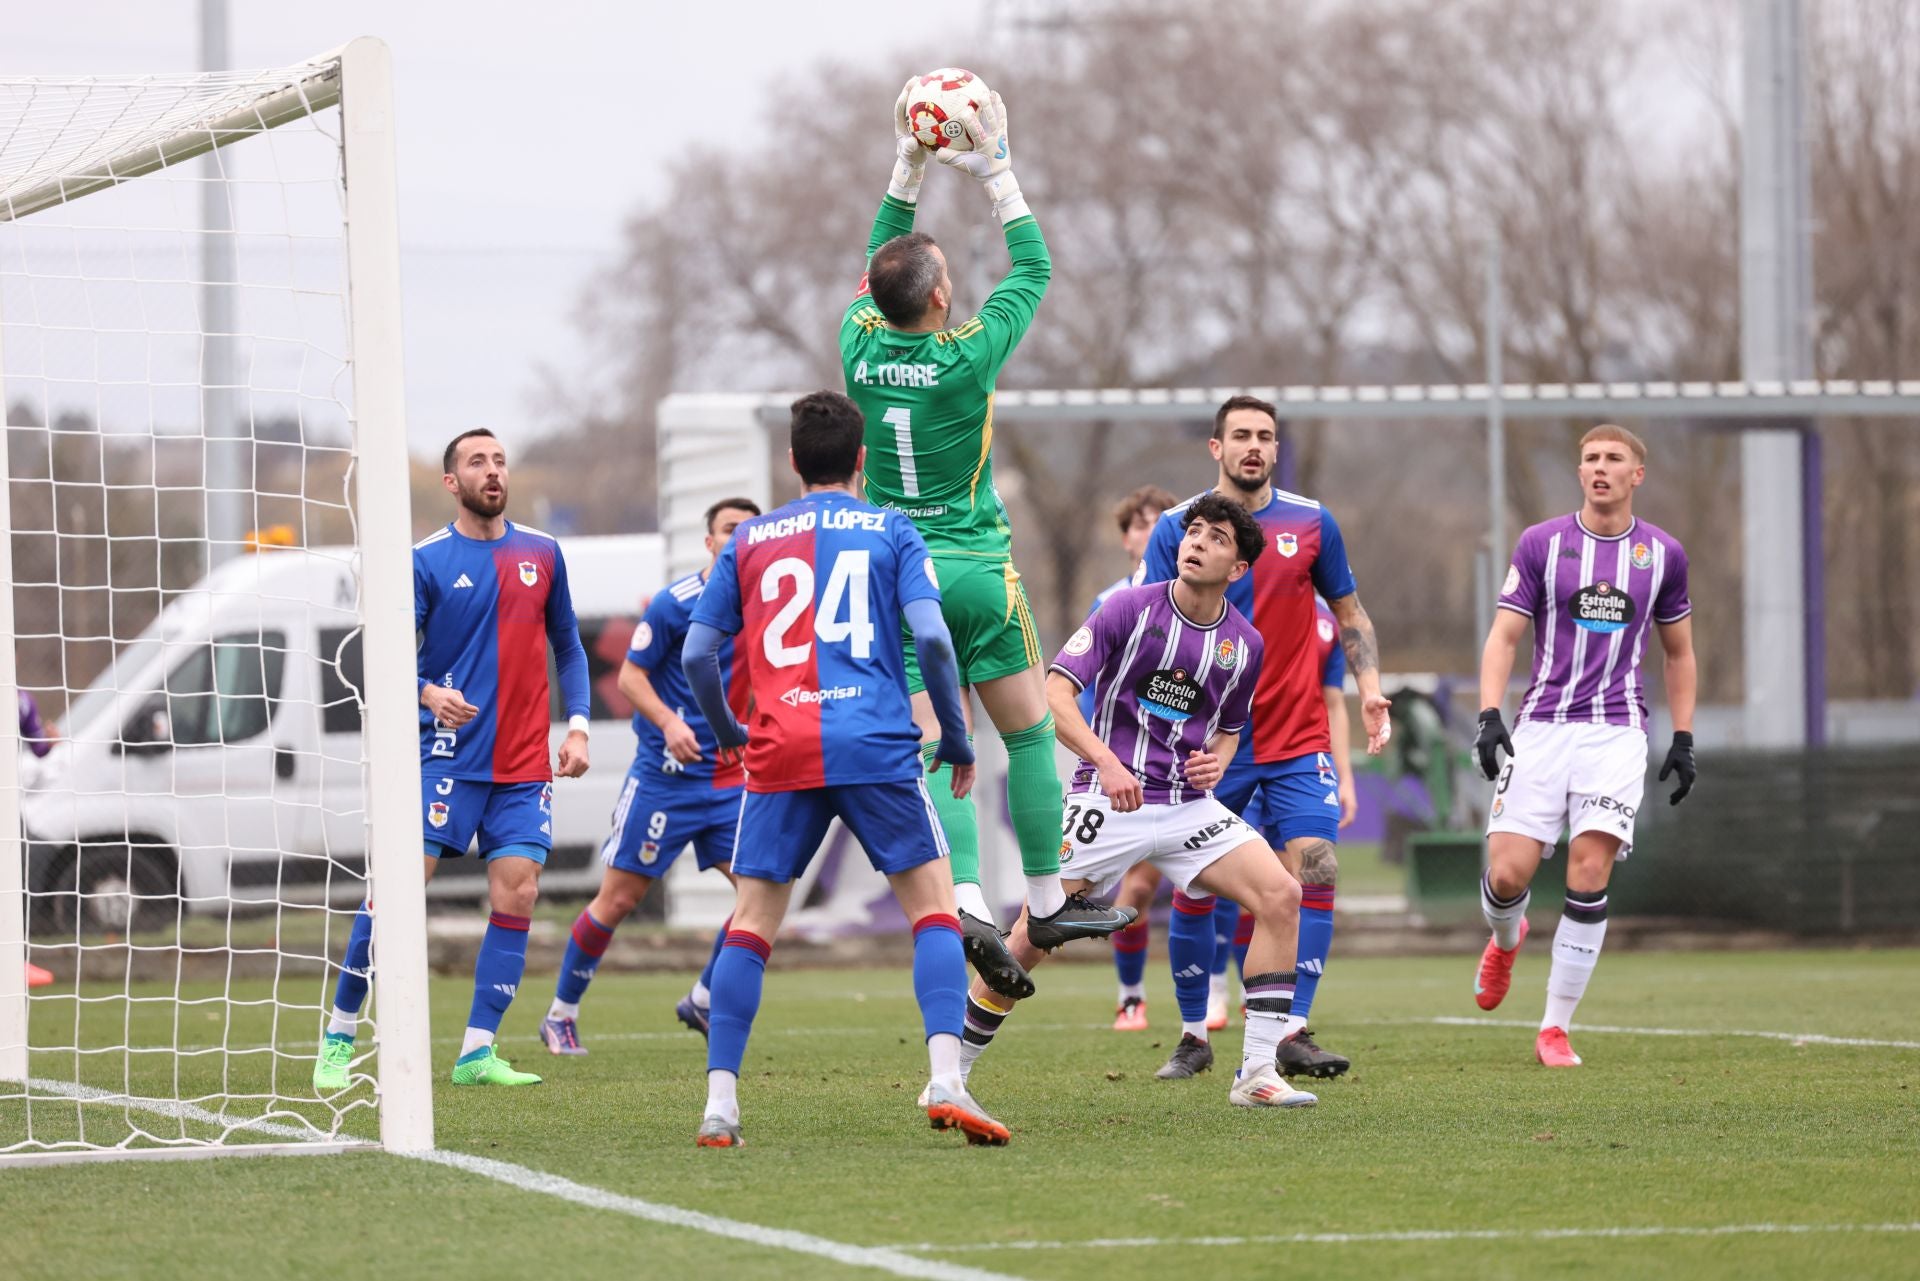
[1473,424,1697,1068]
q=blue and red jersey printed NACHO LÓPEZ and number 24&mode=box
[693,490,941,791]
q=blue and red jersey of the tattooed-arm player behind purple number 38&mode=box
[1140,490,1356,764]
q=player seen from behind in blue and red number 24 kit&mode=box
[684,392,1008,1147]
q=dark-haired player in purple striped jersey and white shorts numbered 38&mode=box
[962,494,1317,1108]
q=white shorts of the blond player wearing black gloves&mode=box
[1486,720,1647,858]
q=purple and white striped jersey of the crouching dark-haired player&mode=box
[1052,582,1261,805]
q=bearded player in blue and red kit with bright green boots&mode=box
[313,430,589,1091]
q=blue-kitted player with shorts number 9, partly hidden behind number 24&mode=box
[540,497,760,1054]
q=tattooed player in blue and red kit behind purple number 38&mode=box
[1142,396,1392,1076]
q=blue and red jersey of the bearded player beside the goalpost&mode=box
[413,520,591,784]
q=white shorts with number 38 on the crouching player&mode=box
[1060,793,1261,893]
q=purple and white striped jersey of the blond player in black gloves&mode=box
[1500,513,1693,730]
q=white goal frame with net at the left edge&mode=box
[0,40,432,1160]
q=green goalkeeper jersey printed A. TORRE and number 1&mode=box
[841,196,1052,561]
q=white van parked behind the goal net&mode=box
[21,534,664,937]
